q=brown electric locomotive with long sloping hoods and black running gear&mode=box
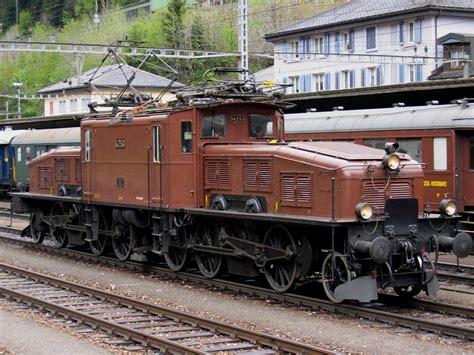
[13,82,472,302]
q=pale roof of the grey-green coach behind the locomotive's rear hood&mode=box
[12,127,81,144]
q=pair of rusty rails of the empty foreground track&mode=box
[0,263,335,354]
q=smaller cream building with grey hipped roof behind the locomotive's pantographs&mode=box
[37,64,184,116]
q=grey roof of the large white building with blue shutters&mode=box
[265,0,474,40]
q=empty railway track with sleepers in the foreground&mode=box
[0,264,334,354]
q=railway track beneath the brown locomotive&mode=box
[1,232,474,341]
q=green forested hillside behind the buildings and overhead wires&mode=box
[0,0,343,119]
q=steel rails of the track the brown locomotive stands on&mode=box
[0,237,474,340]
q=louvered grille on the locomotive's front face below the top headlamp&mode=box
[362,180,413,213]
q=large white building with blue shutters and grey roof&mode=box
[265,0,474,93]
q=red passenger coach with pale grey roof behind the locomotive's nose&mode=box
[285,101,474,216]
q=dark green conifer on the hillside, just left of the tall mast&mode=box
[163,0,186,48]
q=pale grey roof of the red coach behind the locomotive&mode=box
[285,104,474,134]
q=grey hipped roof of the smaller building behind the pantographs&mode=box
[38,64,184,94]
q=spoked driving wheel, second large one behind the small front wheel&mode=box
[195,221,222,279]
